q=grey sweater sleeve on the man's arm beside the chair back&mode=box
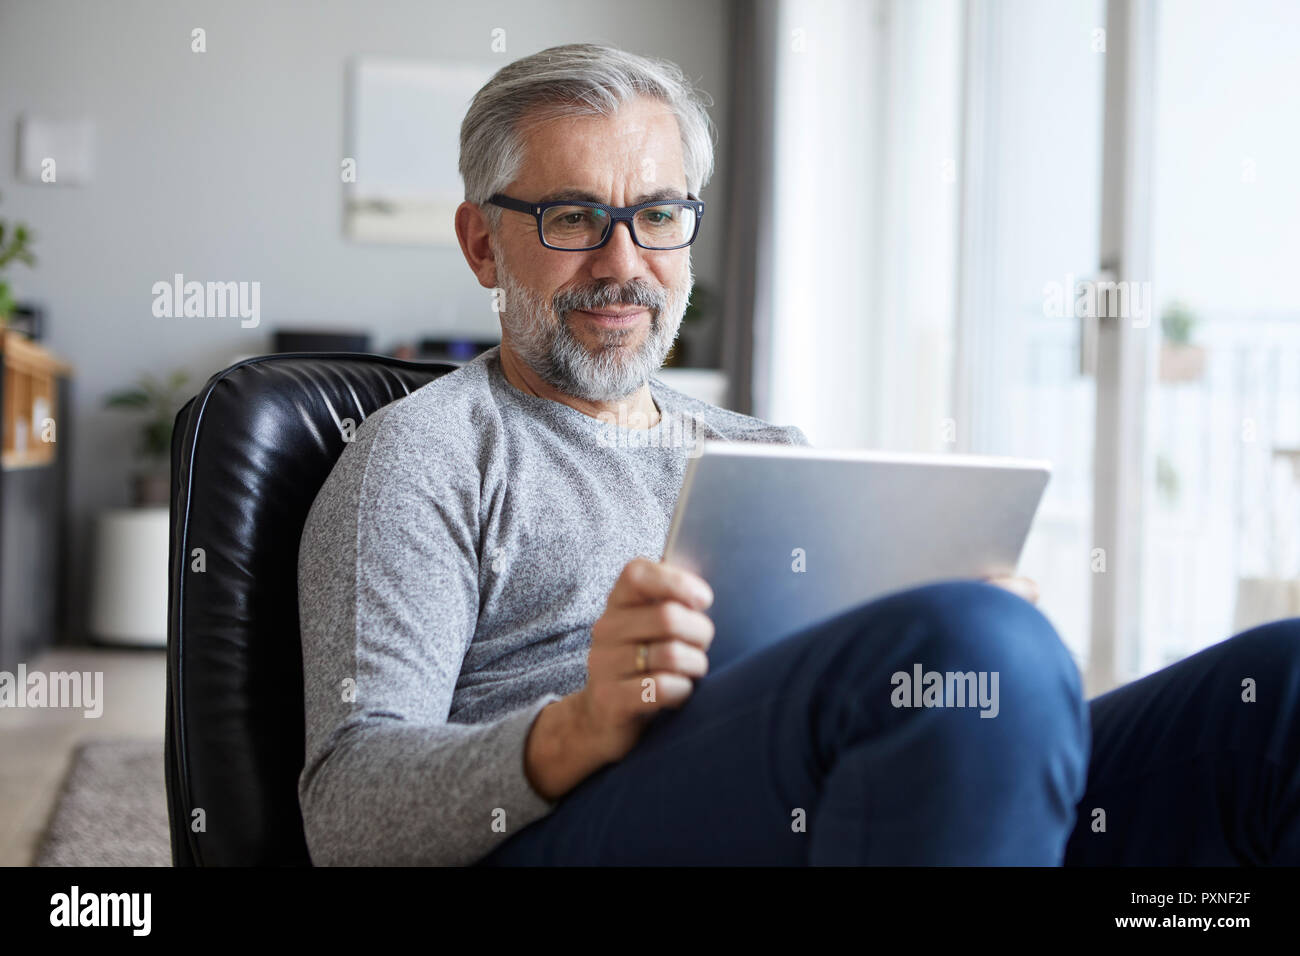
[298,410,560,865]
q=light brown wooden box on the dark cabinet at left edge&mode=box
[0,329,72,471]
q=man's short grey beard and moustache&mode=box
[497,258,694,402]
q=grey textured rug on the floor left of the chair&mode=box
[35,740,172,866]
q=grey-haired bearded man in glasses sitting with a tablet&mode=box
[299,44,1300,864]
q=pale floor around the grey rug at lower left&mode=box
[0,648,166,866]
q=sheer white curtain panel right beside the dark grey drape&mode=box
[754,0,961,450]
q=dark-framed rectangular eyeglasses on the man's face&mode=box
[488,193,705,252]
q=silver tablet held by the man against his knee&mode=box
[663,441,1050,671]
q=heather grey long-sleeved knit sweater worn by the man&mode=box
[298,346,809,865]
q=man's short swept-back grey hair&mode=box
[460,43,714,229]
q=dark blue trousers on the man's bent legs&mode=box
[480,581,1300,866]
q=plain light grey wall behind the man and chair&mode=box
[0,0,728,647]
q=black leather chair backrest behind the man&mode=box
[165,352,456,866]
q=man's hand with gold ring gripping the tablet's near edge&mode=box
[524,558,714,800]
